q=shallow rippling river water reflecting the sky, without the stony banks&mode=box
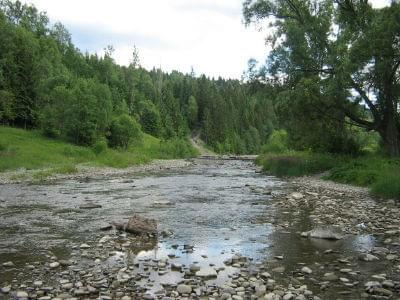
[0,160,394,299]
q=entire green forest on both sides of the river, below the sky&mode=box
[0,0,400,196]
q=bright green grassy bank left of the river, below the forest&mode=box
[0,126,197,175]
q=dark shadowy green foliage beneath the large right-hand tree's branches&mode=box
[277,78,361,155]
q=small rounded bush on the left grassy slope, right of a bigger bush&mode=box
[108,114,142,149]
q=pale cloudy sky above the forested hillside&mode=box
[24,0,389,78]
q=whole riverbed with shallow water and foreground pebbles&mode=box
[0,159,398,300]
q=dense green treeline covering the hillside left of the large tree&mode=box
[0,0,276,153]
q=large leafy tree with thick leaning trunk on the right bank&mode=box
[243,0,400,156]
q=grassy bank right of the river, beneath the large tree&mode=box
[257,152,400,199]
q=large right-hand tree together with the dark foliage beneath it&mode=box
[243,0,400,156]
